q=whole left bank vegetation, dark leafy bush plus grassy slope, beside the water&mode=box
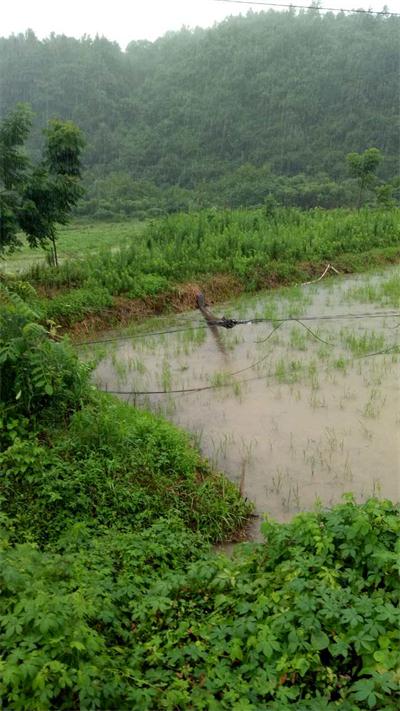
[0,287,251,544]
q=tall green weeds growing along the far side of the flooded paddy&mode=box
[23,207,400,325]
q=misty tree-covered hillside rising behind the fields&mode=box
[0,11,400,214]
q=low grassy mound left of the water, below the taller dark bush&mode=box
[0,396,251,544]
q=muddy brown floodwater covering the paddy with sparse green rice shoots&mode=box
[92,268,400,536]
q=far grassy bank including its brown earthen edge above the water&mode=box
[6,209,400,329]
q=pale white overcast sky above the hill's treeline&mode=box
[0,0,400,49]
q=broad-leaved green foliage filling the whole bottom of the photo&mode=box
[0,500,400,711]
